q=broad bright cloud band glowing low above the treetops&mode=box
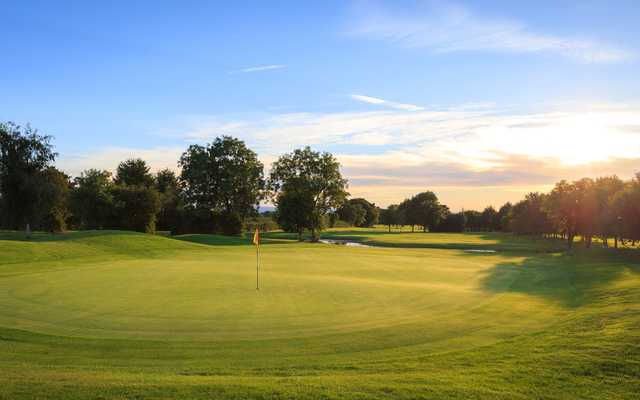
[57,105,640,208]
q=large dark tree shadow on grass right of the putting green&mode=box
[478,249,640,308]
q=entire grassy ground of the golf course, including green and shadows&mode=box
[0,230,640,399]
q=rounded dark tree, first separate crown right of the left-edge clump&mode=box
[71,169,115,229]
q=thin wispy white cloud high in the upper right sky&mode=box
[349,4,634,63]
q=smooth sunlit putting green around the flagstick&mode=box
[0,236,562,342]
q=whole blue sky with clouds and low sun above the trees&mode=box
[0,0,640,210]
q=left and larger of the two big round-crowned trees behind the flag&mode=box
[178,136,264,231]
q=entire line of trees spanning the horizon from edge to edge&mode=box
[0,123,640,247]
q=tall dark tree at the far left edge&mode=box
[0,122,57,229]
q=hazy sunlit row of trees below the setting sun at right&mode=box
[380,174,640,247]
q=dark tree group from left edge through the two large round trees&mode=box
[0,123,348,240]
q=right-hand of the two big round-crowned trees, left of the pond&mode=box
[268,147,347,241]
